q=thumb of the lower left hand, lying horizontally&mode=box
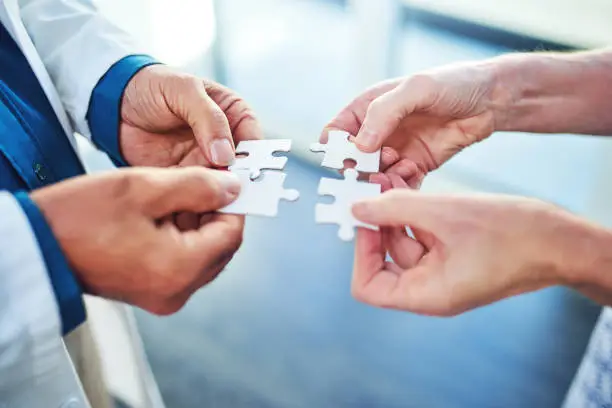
[135,166,240,219]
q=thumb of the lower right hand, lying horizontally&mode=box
[353,189,448,232]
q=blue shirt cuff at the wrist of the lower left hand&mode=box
[15,192,86,335]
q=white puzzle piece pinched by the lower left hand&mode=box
[219,169,300,217]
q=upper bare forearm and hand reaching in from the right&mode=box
[330,49,612,182]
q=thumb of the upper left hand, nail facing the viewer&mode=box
[177,78,236,167]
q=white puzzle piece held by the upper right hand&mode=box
[310,130,380,173]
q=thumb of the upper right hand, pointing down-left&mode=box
[355,79,435,152]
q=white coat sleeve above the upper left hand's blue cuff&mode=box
[18,0,144,139]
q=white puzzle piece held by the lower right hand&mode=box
[315,169,381,241]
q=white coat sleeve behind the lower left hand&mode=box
[0,191,88,408]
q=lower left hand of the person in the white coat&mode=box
[32,167,244,314]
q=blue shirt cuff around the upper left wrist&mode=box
[87,55,159,167]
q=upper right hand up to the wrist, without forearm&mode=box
[321,63,504,186]
